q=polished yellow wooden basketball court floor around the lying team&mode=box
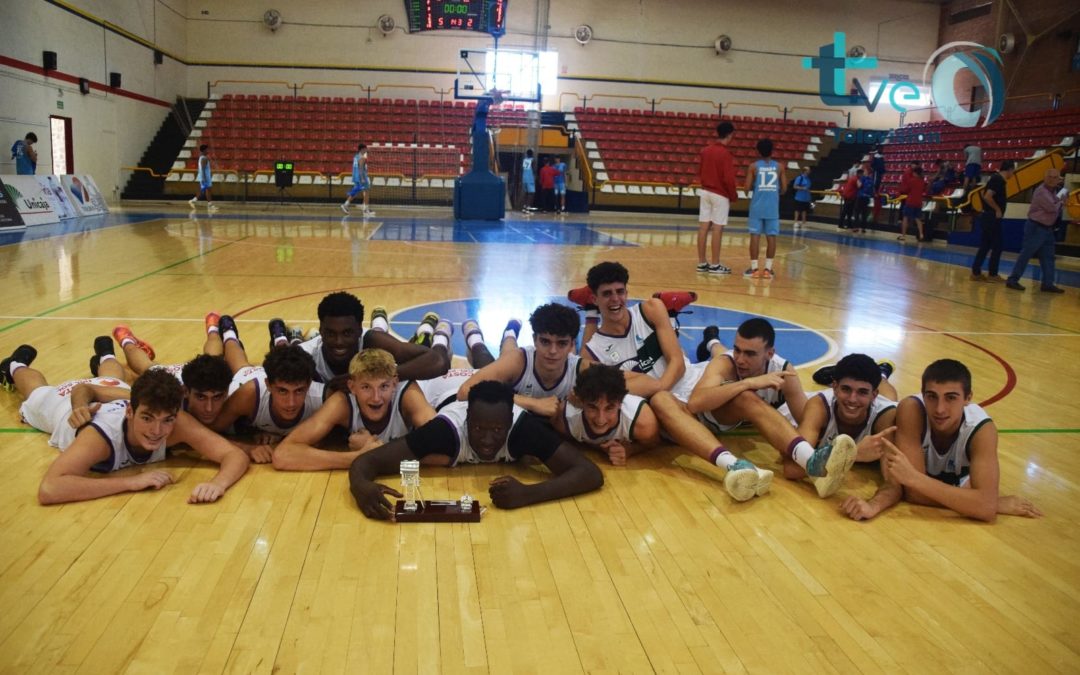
[0,205,1080,674]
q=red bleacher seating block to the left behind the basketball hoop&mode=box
[183,94,526,178]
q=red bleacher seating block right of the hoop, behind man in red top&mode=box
[573,107,827,186]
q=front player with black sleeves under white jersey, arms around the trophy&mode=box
[349,381,604,519]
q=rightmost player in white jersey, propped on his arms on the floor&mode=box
[841,359,1042,522]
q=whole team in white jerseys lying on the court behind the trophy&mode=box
[0,262,1041,521]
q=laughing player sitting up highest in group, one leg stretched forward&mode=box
[571,262,772,501]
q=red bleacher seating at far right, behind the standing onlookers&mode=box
[881,108,1080,193]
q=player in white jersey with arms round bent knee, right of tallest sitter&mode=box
[682,318,855,497]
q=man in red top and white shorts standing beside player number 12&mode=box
[698,122,739,274]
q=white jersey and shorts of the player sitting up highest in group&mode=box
[585,303,707,403]
